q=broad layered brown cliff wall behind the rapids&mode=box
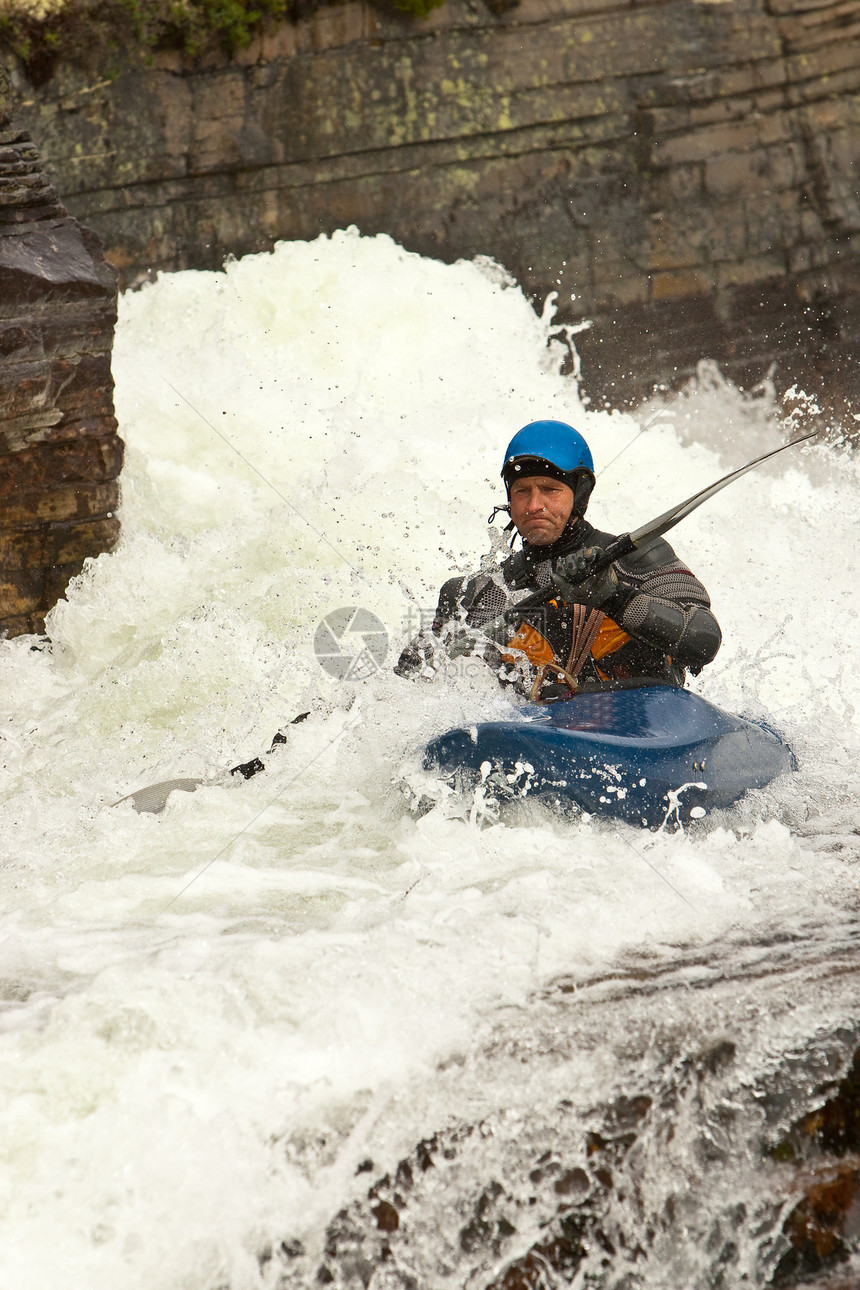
[6,0,860,400]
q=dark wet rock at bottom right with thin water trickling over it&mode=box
[264,1031,860,1290]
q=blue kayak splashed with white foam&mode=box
[424,685,797,828]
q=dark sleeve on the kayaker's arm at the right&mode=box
[603,538,722,673]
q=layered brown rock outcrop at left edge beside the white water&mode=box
[0,72,122,636]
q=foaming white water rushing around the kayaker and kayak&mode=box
[0,233,860,1290]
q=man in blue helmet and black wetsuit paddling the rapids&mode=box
[396,421,721,702]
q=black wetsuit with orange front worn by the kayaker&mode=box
[396,519,721,699]
